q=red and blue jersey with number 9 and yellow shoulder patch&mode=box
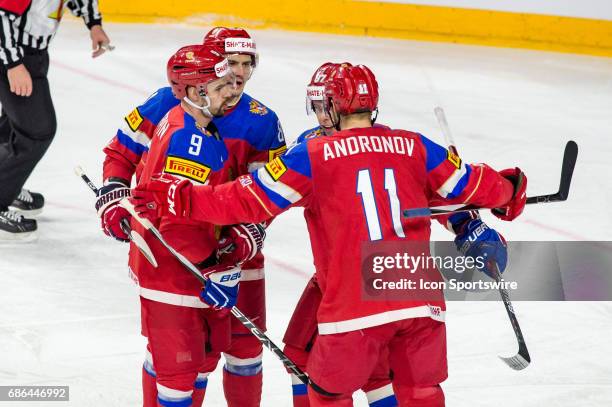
[129,106,230,308]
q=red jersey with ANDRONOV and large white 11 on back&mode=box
[154,128,513,328]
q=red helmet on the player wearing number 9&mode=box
[167,45,230,99]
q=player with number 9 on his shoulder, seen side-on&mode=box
[96,45,262,407]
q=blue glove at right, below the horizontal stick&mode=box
[455,219,508,278]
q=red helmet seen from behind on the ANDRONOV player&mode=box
[324,64,378,116]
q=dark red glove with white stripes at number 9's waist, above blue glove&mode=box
[217,223,266,264]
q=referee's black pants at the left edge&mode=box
[0,49,57,210]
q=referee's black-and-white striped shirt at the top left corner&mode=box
[0,0,102,69]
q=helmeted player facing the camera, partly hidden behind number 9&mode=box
[100,27,286,407]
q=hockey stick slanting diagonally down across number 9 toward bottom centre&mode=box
[121,198,338,397]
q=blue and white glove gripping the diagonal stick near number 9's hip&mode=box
[200,264,241,310]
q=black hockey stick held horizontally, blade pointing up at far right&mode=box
[403,140,578,218]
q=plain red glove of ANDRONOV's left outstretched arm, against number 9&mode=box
[130,174,191,220]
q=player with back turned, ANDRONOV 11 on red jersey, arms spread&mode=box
[132,66,527,407]
